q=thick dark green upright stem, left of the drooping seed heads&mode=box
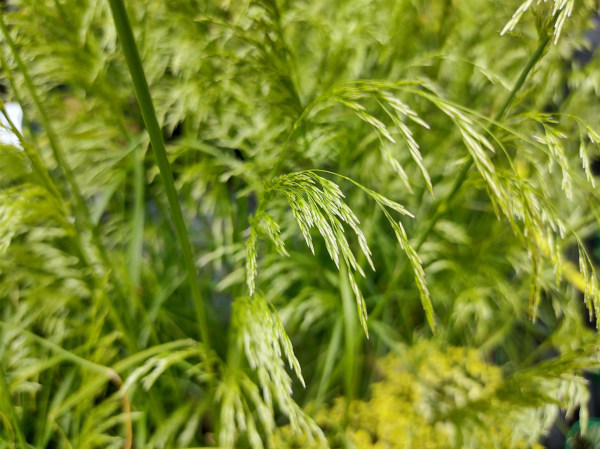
[109,0,210,346]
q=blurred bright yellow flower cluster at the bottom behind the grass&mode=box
[277,342,541,449]
